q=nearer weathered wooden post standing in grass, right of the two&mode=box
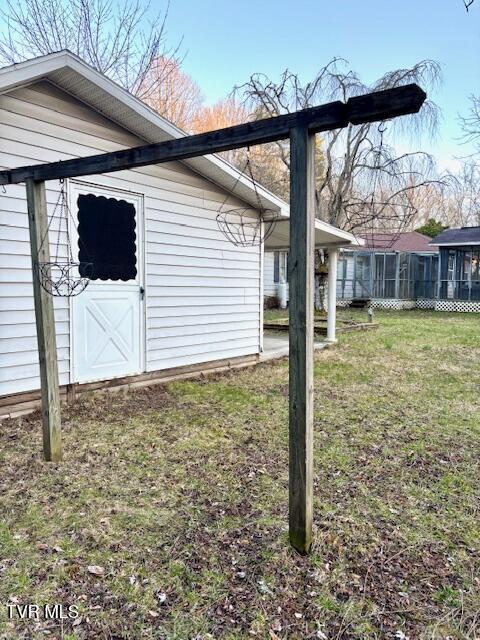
[288,125,315,553]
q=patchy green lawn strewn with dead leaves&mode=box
[0,312,480,640]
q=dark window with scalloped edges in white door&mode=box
[77,193,137,280]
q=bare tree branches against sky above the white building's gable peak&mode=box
[0,0,180,99]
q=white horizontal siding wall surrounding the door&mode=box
[0,82,260,395]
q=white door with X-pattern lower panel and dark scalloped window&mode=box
[70,182,144,382]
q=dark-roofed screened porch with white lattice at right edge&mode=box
[431,227,480,311]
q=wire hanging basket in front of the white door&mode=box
[36,180,93,298]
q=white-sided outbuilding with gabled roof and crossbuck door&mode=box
[0,52,353,416]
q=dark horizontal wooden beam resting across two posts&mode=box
[0,84,426,185]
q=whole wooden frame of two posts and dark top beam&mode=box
[8,84,426,553]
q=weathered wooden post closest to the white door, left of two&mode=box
[26,178,62,462]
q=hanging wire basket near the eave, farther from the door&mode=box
[217,148,278,247]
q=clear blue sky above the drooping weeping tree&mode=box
[168,0,480,166]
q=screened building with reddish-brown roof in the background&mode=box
[337,231,438,309]
